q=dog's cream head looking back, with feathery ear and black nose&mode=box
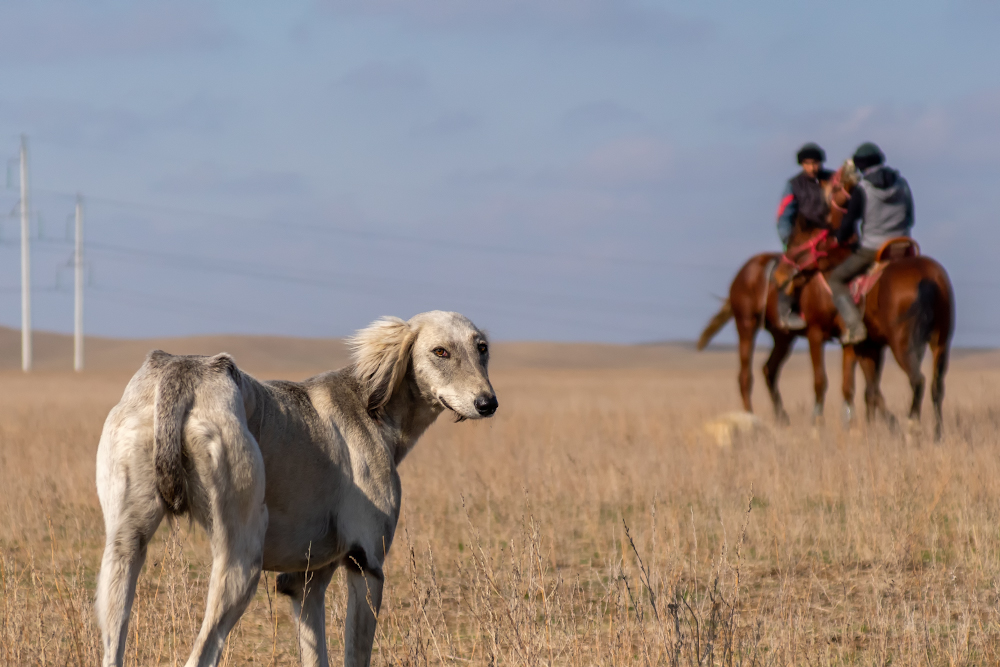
[350,310,497,420]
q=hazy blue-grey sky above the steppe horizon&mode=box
[0,0,1000,346]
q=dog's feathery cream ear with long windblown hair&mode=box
[348,317,417,419]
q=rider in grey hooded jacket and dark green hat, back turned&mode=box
[827,141,913,344]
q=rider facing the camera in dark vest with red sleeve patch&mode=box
[778,142,833,330]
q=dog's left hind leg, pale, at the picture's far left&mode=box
[96,435,164,667]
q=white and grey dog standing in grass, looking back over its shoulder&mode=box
[97,311,497,667]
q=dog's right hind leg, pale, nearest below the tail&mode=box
[181,429,267,667]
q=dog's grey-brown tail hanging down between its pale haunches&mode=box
[148,350,197,514]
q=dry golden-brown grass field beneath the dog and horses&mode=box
[0,336,1000,665]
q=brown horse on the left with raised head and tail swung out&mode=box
[697,160,860,424]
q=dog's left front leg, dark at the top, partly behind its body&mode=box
[277,563,337,667]
